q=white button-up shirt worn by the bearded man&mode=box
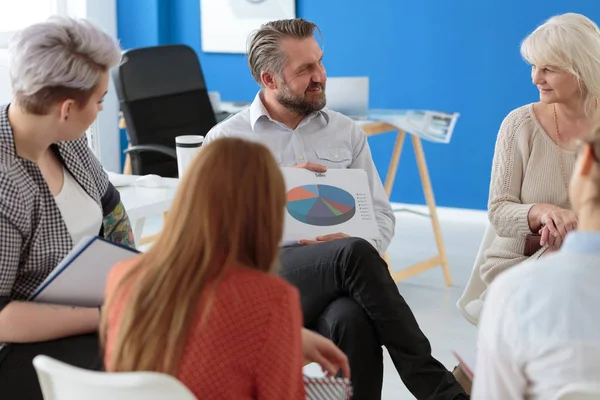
[204,92,396,254]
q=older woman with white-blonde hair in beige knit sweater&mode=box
[481,13,600,285]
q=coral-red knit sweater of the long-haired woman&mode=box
[105,260,306,400]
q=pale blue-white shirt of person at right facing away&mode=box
[472,231,600,400]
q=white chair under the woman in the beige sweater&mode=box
[456,223,496,326]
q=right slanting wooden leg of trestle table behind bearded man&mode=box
[411,135,452,286]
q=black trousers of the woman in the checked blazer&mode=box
[0,333,103,400]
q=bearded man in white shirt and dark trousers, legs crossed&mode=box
[204,18,467,400]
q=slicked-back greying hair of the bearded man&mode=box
[248,18,321,86]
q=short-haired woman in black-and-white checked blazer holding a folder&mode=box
[0,18,133,399]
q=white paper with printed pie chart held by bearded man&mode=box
[282,168,379,243]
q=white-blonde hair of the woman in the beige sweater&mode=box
[521,13,600,99]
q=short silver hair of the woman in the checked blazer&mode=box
[9,16,121,115]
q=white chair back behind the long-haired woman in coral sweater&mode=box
[33,355,197,400]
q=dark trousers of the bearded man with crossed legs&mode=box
[280,238,467,400]
